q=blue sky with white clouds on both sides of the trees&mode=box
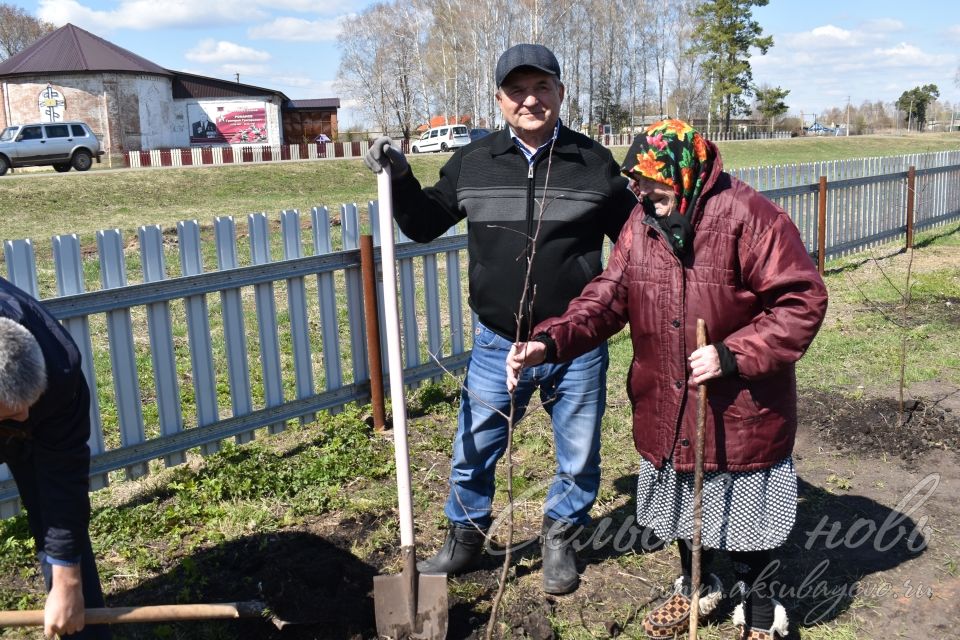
[7,0,960,125]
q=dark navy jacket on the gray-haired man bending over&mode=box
[0,278,90,562]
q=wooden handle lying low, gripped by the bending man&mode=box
[0,600,267,627]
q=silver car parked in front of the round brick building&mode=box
[0,122,103,176]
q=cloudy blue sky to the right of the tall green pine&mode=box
[751,0,960,121]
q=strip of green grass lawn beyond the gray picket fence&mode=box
[0,133,960,244]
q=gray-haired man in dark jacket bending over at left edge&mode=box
[0,278,110,639]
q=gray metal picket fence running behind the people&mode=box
[0,151,960,518]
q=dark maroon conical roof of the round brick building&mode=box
[0,24,171,76]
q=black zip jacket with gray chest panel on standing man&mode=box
[393,126,637,340]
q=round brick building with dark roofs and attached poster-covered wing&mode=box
[0,24,340,153]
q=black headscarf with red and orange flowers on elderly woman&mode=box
[620,120,713,216]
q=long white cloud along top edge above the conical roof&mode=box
[37,0,266,34]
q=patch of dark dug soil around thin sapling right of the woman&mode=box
[798,391,960,464]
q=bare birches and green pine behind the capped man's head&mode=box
[338,0,789,137]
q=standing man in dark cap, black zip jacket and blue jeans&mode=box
[365,44,636,593]
